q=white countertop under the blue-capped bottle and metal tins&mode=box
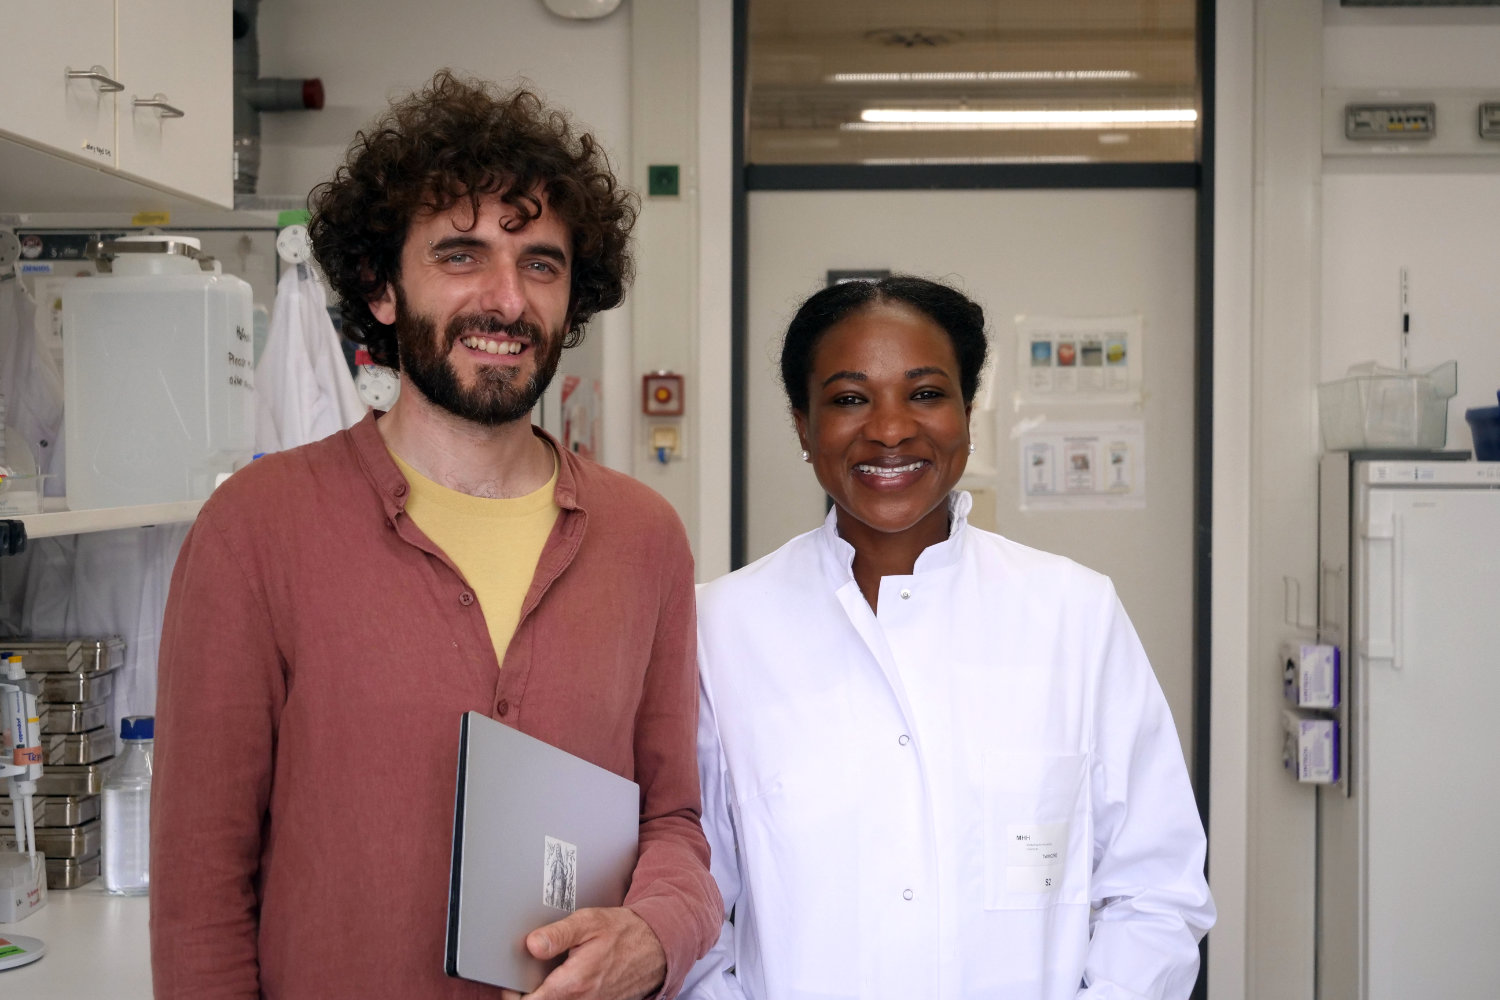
[0,879,152,1000]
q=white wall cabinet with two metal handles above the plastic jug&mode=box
[0,0,234,211]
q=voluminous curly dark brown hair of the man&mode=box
[308,69,639,369]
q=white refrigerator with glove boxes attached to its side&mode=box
[1316,453,1500,1000]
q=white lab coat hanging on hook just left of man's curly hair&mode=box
[255,264,366,453]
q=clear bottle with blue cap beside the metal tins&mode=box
[104,715,156,895]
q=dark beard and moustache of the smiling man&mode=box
[396,285,563,427]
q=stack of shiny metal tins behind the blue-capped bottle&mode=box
[0,637,125,889]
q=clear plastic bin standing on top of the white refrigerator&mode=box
[1317,361,1458,451]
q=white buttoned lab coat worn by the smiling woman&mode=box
[684,493,1214,1000]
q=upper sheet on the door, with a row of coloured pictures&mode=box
[1016,315,1145,403]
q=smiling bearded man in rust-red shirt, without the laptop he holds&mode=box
[152,70,720,1000]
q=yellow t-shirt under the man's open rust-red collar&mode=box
[390,453,560,664]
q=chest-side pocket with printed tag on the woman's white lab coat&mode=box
[984,753,1089,910]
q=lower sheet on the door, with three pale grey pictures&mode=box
[1019,420,1146,510]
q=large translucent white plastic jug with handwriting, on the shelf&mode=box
[63,235,255,510]
